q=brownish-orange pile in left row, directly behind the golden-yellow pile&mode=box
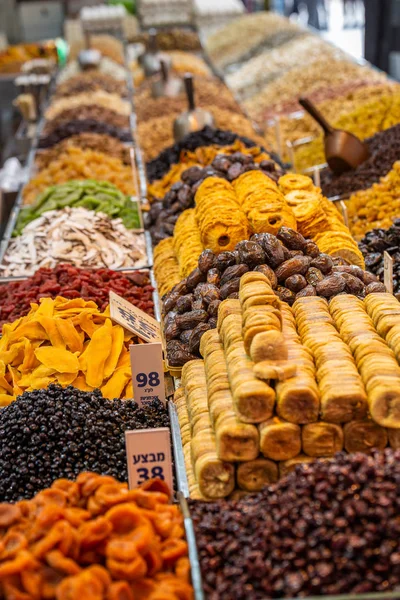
[35,133,131,171]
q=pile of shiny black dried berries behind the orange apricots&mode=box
[0,385,169,502]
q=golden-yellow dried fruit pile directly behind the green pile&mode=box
[23,147,136,204]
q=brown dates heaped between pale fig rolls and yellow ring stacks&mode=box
[163,227,386,367]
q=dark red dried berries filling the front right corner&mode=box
[190,450,400,600]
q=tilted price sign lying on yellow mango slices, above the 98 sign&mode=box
[109,292,161,342]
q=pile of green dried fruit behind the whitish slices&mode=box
[17,179,140,236]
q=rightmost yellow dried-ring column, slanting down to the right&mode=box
[278,174,364,268]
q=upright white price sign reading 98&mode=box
[129,342,165,405]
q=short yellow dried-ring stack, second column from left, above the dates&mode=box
[173,208,203,279]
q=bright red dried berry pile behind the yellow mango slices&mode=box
[0,264,154,327]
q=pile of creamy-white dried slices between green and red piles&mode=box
[0,208,147,277]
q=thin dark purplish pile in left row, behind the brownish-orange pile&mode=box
[38,119,132,148]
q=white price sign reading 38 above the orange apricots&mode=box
[125,427,173,492]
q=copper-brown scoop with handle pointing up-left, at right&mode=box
[299,98,369,175]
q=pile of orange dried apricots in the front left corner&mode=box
[0,472,193,600]
